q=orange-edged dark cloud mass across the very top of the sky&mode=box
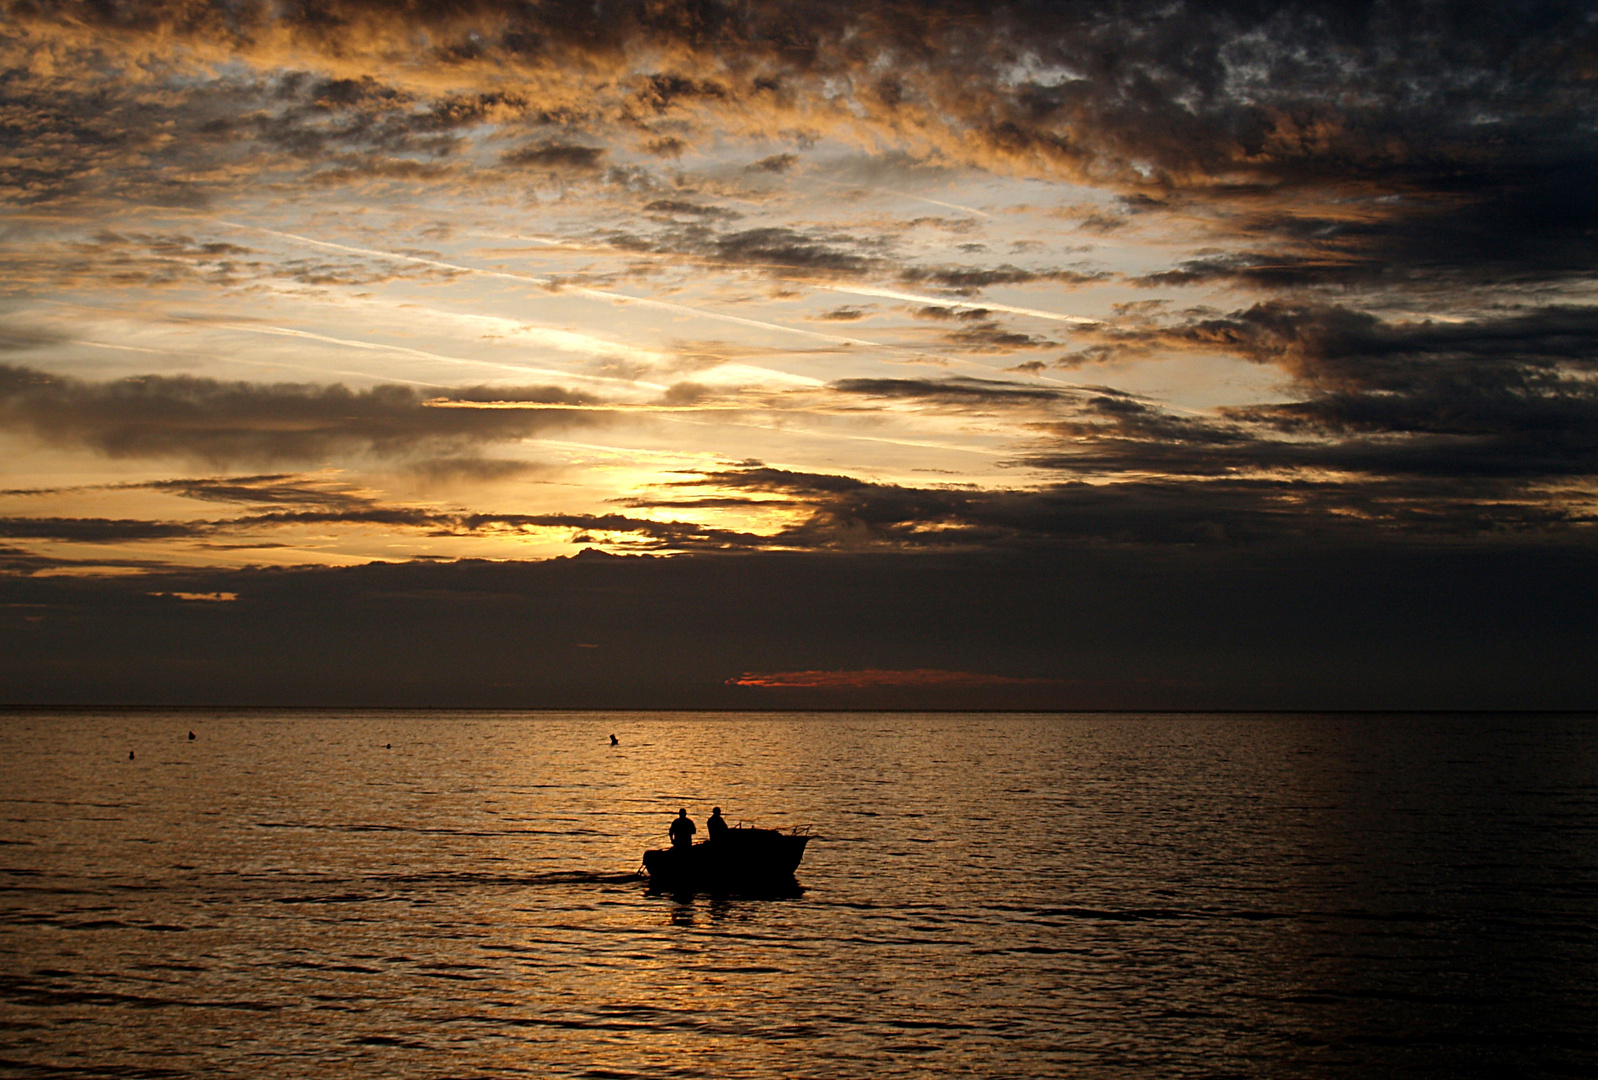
[0,0,1598,291]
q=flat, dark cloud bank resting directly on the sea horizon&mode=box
[0,545,1598,709]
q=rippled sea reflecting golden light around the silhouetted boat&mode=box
[0,713,1598,1078]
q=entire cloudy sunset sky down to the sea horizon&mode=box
[0,0,1598,709]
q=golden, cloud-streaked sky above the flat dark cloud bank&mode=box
[0,0,1598,572]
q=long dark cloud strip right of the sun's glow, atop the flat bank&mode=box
[655,463,1598,553]
